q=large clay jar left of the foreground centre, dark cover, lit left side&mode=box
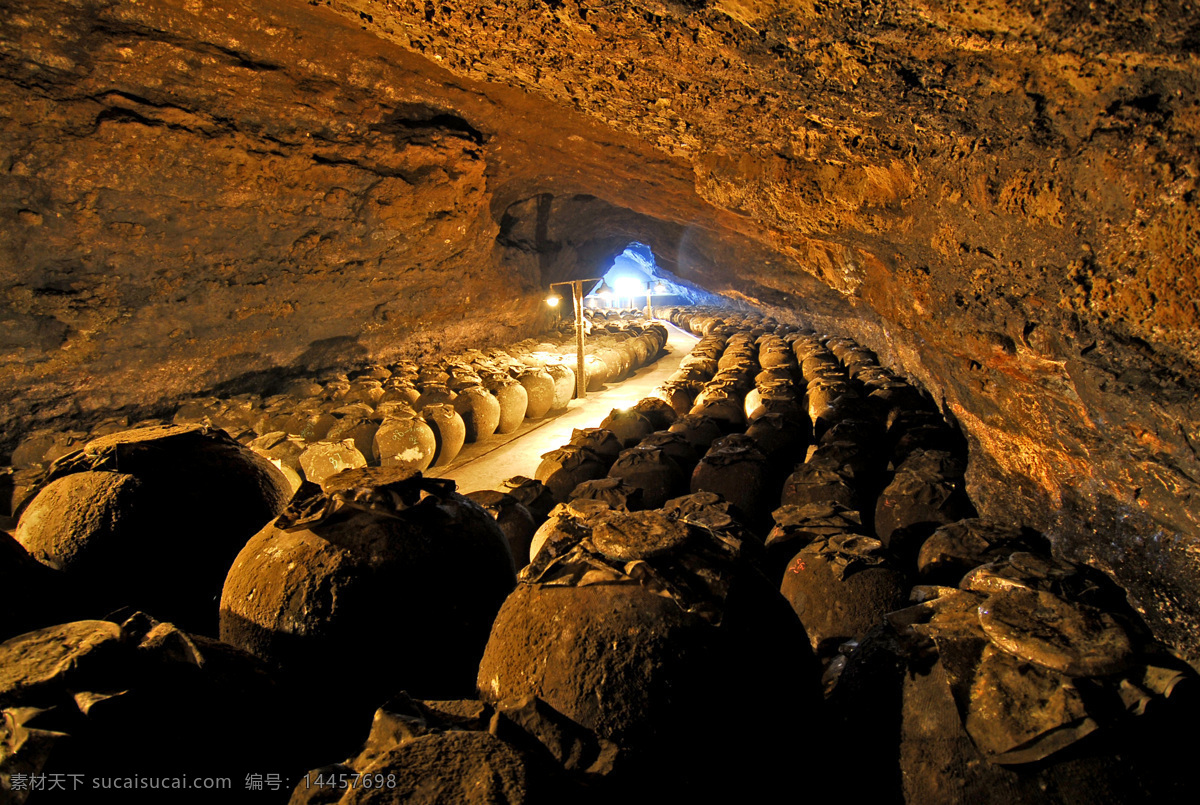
[221,468,515,713]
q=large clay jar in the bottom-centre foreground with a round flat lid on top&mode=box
[476,511,820,801]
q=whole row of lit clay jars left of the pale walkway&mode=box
[0,319,667,515]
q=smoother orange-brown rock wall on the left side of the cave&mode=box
[0,0,782,427]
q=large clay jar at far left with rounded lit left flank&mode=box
[16,426,292,635]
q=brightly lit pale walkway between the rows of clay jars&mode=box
[425,320,700,494]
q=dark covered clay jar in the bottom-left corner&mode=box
[0,619,304,791]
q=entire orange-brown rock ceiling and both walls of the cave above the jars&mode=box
[0,0,1200,661]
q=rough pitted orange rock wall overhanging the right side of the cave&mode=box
[330,0,1200,659]
